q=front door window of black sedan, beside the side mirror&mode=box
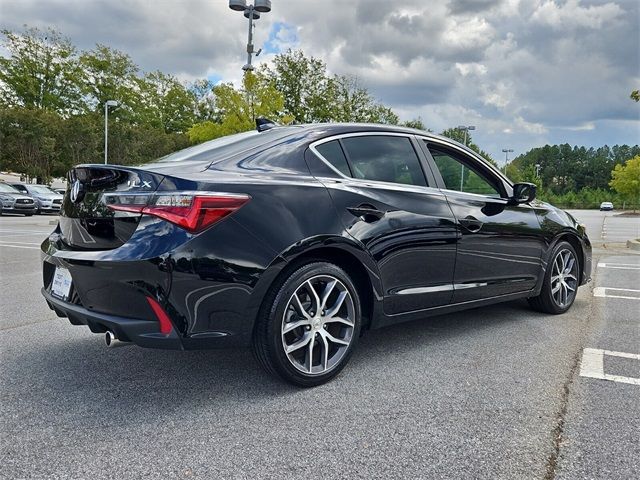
[429,145,501,198]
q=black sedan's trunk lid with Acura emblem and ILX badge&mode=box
[60,165,164,250]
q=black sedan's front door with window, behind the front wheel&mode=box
[423,140,544,303]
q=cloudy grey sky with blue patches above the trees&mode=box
[0,0,640,163]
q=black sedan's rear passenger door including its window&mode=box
[310,132,458,315]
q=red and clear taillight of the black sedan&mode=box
[104,192,251,233]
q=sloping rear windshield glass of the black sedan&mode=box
[157,127,299,163]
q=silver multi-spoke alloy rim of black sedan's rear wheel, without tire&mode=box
[281,275,355,375]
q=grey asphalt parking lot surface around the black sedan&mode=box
[0,211,640,479]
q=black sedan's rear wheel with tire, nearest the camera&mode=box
[253,262,361,387]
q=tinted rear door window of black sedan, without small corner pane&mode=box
[341,135,427,186]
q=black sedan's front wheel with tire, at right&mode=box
[527,241,580,315]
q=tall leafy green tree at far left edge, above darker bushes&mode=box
[0,28,81,115]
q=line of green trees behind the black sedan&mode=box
[0,28,640,206]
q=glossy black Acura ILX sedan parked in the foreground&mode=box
[42,124,591,386]
